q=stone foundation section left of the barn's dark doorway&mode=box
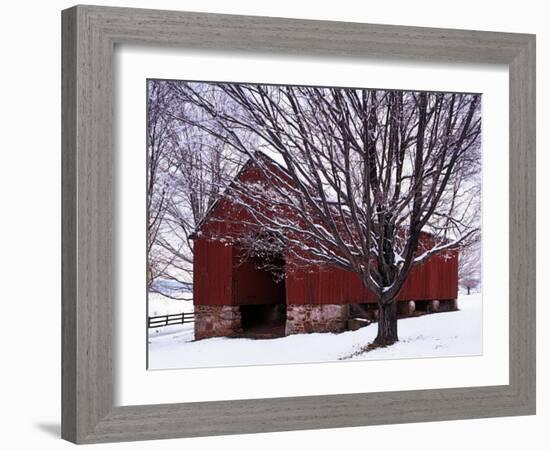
[195,305,242,340]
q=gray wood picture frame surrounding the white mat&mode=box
[62,6,535,443]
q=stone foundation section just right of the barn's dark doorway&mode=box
[286,305,348,335]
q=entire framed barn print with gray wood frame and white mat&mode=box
[62,6,535,443]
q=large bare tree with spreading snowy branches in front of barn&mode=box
[173,83,481,345]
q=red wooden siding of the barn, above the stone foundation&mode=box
[193,156,458,305]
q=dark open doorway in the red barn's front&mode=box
[233,248,286,338]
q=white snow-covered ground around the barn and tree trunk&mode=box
[149,294,482,369]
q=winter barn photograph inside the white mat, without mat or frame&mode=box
[144,79,483,370]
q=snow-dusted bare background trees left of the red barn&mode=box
[147,80,245,300]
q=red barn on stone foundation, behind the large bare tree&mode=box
[192,156,458,339]
